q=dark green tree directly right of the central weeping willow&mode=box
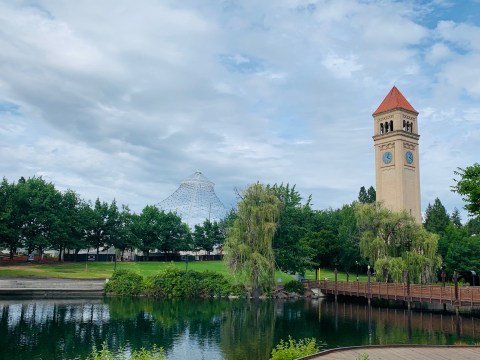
[271,184,313,274]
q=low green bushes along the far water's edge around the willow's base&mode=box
[105,267,313,299]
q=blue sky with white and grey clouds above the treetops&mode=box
[0,0,480,221]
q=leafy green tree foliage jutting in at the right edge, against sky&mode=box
[452,163,480,216]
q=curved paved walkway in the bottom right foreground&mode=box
[304,345,480,360]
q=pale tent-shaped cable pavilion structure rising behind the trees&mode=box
[158,170,227,228]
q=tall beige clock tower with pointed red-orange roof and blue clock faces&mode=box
[373,86,421,223]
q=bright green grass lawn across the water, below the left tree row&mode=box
[0,261,292,283]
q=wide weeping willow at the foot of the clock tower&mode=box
[355,203,441,283]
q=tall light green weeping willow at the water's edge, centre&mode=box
[224,183,280,295]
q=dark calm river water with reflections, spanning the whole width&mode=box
[0,299,480,360]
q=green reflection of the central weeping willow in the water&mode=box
[220,300,275,360]
